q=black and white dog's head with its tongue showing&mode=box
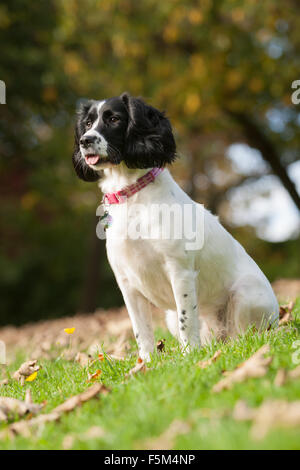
[73,93,176,181]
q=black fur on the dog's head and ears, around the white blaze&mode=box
[72,93,176,181]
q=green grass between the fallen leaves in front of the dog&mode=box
[0,299,300,450]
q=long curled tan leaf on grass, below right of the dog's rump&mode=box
[212,344,272,393]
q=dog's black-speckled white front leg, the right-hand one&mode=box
[171,270,200,352]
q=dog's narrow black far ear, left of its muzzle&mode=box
[72,100,100,182]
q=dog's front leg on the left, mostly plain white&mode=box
[119,282,154,362]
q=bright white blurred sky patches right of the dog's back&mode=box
[226,143,300,242]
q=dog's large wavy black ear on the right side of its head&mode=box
[121,93,176,168]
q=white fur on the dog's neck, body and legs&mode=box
[100,163,278,360]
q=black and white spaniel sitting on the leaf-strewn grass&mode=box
[73,93,278,360]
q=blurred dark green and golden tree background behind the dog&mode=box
[0,0,300,325]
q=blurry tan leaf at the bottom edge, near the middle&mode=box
[143,419,191,450]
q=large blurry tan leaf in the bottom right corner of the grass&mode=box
[233,400,300,439]
